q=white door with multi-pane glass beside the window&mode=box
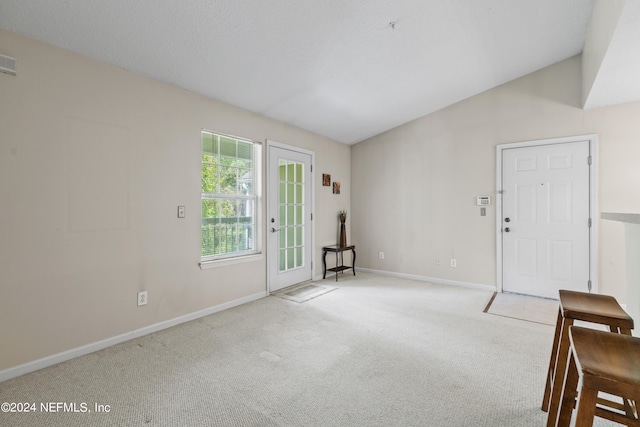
[267,143,313,292]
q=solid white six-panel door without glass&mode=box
[502,140,590,298]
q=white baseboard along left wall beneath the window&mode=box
[0,291,268,382]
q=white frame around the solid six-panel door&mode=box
[496,134,600,293]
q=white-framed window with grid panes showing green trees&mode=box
[201,131,261,261]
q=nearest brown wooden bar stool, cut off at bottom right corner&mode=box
[554,326,640,427]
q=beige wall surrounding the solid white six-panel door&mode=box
[351,56,640,302]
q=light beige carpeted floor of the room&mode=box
[0,272,613,427]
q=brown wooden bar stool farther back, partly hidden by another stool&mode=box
[542,290,633,427]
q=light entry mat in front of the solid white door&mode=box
[484,292,559,326]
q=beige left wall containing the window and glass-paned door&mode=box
[0,31,350,371]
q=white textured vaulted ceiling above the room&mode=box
[0,0,640,144]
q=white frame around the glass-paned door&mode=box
[263,139,316,294]
